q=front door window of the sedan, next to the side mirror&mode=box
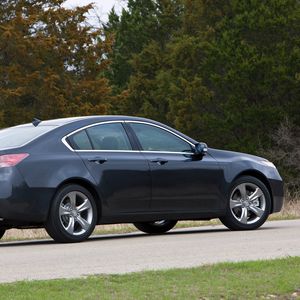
[130,123,192,152]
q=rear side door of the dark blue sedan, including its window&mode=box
[68,121,151,216]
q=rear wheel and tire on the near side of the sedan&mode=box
[45,184,97,243]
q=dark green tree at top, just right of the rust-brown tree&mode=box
[105,0,182,91]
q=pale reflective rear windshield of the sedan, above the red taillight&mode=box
[0,125,56,150]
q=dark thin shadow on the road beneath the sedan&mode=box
[0,225,277,249]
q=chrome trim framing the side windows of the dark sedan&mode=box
[61,120,195,155]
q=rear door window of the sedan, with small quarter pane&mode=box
[68,123,132,150]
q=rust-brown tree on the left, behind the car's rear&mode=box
[0,0,111,126]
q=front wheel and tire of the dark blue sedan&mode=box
[220,176,271,230]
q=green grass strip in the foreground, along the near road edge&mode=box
[0,256,300,300]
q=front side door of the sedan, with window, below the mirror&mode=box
[128,122,222,212]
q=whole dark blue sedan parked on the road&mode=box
[0,116,283,242]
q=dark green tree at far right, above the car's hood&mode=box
[195,0,300,153]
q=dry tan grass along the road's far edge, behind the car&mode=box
[1,200,300,241]
